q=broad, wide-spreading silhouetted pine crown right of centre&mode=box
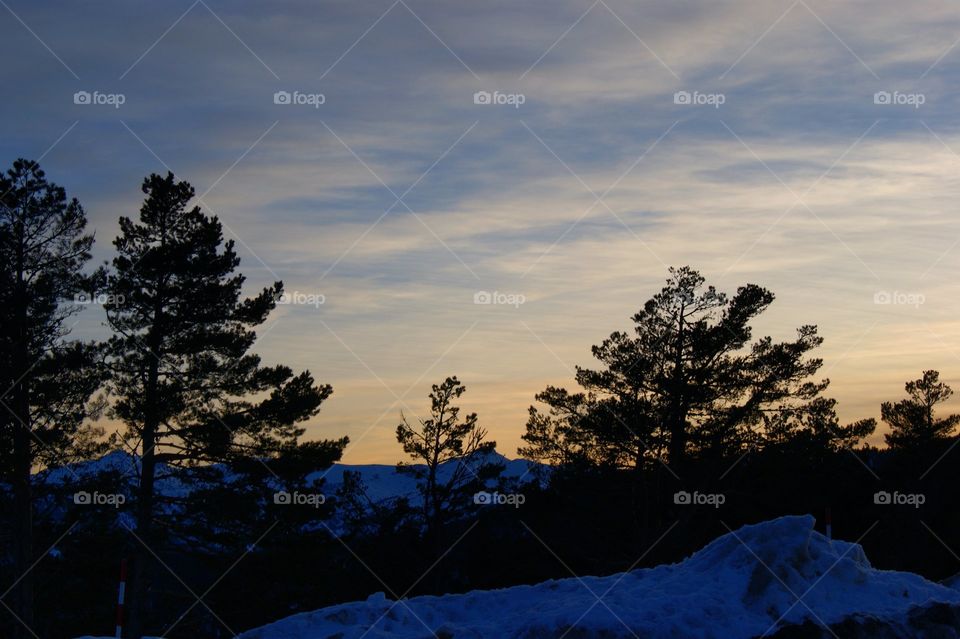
[520,267,868,468]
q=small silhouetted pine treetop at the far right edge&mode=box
[880,370,960,448]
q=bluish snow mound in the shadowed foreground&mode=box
[239,516,960,639]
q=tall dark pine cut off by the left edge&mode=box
[0,159,102,637]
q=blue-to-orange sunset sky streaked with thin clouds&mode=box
[0,0,960,463]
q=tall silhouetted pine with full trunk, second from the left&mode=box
[106,173,332,639]
